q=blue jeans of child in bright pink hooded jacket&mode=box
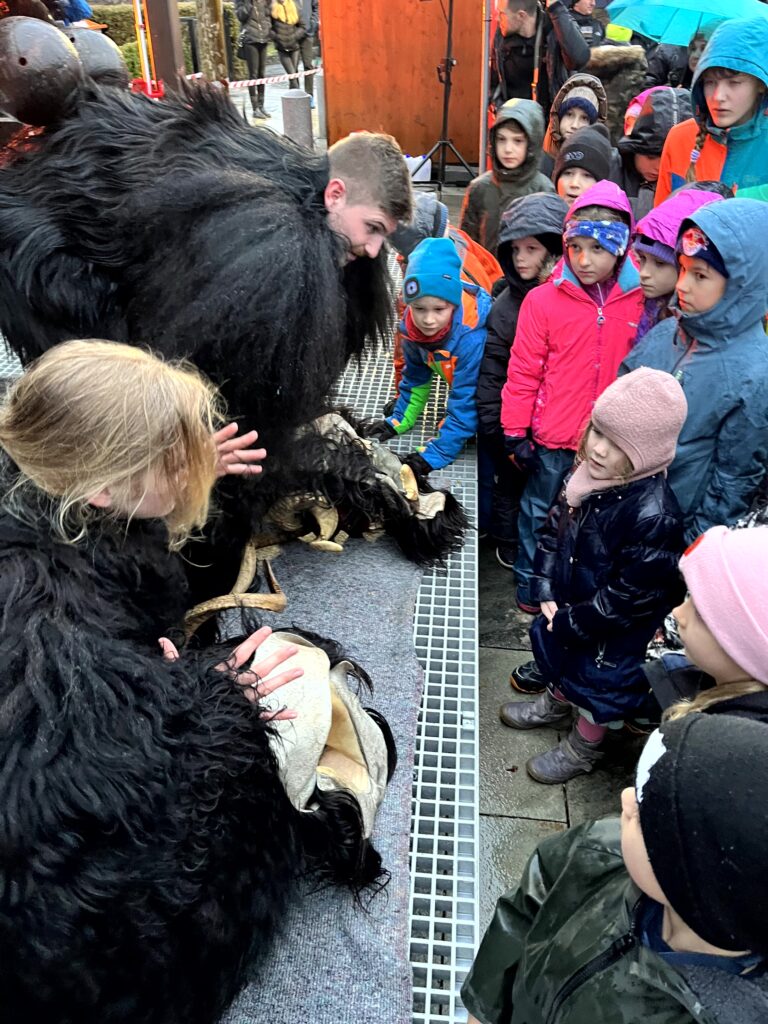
[515,444,575,604]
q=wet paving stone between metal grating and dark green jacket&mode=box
[478,815,565,937]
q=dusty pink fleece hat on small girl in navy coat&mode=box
[592,367,688,478]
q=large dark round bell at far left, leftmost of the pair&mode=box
[0,17,83,125]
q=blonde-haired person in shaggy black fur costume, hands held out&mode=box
[0,340,311,1024]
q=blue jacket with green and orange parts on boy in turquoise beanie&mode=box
[387,283,490,469]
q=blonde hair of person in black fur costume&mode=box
[0,340,221,547]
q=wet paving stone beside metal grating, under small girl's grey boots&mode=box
[479,647,567,822]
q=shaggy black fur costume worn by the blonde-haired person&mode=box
[0,466,389,1024]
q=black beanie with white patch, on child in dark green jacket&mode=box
[636,712,768,956]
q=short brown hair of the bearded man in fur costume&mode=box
[328,131,414,221]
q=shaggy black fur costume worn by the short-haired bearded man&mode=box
[0,79,466,600]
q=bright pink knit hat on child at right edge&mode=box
[680,526,768,685]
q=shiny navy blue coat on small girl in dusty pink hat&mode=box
[530,473,684,722]
